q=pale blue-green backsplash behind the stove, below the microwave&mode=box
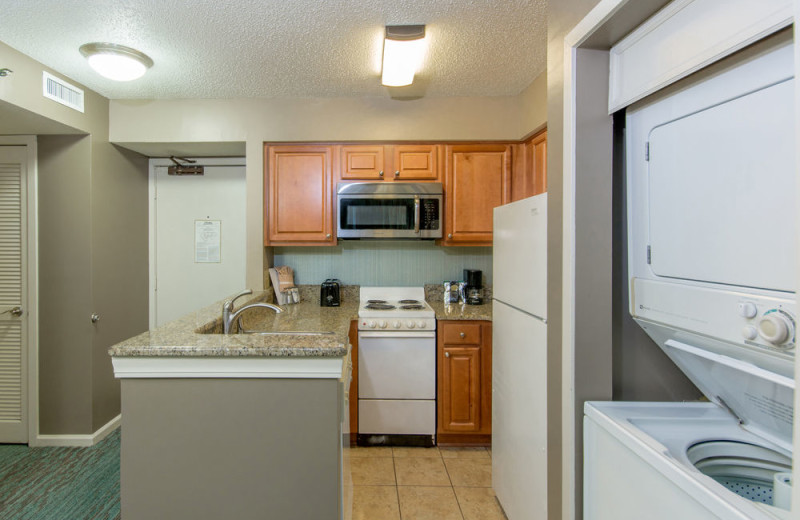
[273,240,492,286]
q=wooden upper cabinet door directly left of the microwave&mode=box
[264,146,336,245]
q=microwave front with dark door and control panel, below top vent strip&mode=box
[336,195,442,239]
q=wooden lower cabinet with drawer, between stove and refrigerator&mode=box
[436,320,492,446]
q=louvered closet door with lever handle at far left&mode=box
[0,146,28,442]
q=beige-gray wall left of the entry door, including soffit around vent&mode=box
[0,43,148,435]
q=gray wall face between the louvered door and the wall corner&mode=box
[38,136,93,434]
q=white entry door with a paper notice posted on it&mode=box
[150,158,245,328]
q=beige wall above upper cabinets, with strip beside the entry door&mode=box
[109,79,546,289]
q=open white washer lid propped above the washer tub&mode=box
[664,339,794,452]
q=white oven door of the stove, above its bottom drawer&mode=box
[358,331,436,399]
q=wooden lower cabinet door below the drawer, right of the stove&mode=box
[439,345,481,433]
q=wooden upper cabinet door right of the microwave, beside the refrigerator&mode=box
[442,144,511,246]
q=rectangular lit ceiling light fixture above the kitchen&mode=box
[381,25,425,87]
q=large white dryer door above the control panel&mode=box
[648,80,797,292]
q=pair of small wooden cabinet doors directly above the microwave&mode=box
[339,144,441,181]
